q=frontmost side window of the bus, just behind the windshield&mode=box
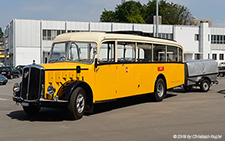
[98,42,115,63]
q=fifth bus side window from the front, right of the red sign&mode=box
[167,46,178,62]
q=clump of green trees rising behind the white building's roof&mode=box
[100,0,193,25]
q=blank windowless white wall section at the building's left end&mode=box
[14,20,41,65]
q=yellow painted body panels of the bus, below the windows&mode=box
[41,62,184,102]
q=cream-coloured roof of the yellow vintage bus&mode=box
[54,32,182,48]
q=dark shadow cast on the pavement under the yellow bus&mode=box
[7,93,176,122]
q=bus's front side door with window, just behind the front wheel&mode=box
[95,42,117,101]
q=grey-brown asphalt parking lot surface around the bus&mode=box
[0,78,225,141]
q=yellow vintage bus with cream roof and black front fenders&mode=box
[13,32,185,119]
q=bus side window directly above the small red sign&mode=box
[153,45,166,62]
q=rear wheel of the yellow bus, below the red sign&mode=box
[153,78,166,102]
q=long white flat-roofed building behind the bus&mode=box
[5,19,225,66]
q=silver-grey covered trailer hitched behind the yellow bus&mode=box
[183,59,218,92]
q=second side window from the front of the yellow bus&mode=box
[117,42,135,62]
